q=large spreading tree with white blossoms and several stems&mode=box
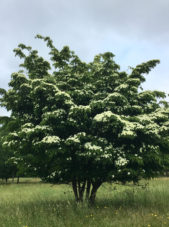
[1,35,169,202]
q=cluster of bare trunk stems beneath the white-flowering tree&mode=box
[72,179,102,204]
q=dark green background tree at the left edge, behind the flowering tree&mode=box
[0,117,34,183]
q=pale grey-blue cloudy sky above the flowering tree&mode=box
[0,0,169,115]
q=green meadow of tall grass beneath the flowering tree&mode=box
[0,178,169,227]
